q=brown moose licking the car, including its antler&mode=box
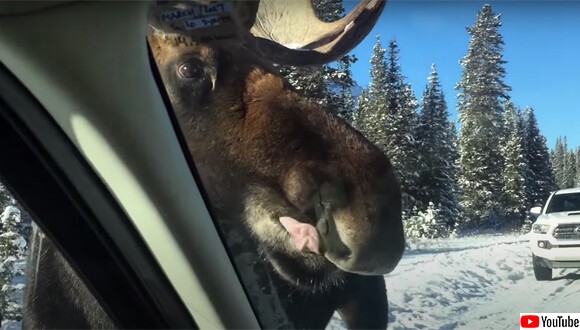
[23,0,405,329]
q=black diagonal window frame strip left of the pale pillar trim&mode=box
[0,63,198,329]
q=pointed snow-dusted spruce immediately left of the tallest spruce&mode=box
[417,64,459,228]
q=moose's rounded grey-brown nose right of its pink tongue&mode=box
[313,177,405,275]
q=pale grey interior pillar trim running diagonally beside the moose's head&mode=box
[0,0,259,329]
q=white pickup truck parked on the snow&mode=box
[529,188,580,281]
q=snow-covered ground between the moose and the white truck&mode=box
[327,235,580,329]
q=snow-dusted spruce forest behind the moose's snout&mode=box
[282,0,580,238]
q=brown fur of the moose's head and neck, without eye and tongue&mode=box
[150,37,404,327]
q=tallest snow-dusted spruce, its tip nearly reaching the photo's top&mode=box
[455,4,510,227]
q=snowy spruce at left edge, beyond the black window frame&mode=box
[0,205,26,323]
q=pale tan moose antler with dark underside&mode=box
[250,0,386,65]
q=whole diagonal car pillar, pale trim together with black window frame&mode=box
[0,1,259,328]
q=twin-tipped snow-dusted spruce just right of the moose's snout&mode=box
[355,36,418,215]
